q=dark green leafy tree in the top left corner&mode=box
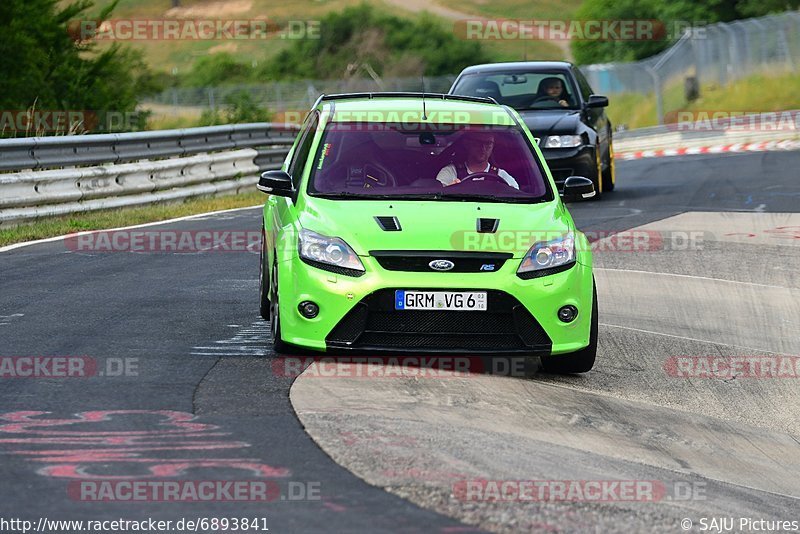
[0,0,158,134]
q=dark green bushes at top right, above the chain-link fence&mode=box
[571,0,800,64]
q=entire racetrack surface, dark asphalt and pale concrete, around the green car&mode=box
[0,152,800,532]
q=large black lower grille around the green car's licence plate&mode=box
[325,289,552,353]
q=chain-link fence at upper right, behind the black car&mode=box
[581,11,800,124]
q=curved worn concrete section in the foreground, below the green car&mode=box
[291,371,800,531]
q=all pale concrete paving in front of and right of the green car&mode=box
[290,208,800,532]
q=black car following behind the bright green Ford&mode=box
[450,61,616,196]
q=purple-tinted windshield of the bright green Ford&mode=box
[308,122,553,202]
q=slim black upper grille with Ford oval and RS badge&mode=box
[369,250,512,273]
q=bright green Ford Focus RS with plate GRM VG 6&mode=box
[258,93,598,373]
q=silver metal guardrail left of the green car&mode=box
[0,123,297,226]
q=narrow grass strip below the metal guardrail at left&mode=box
[0,191,267,247]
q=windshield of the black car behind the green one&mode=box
[451,71,579,111]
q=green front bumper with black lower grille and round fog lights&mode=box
[278,256,593,355]
